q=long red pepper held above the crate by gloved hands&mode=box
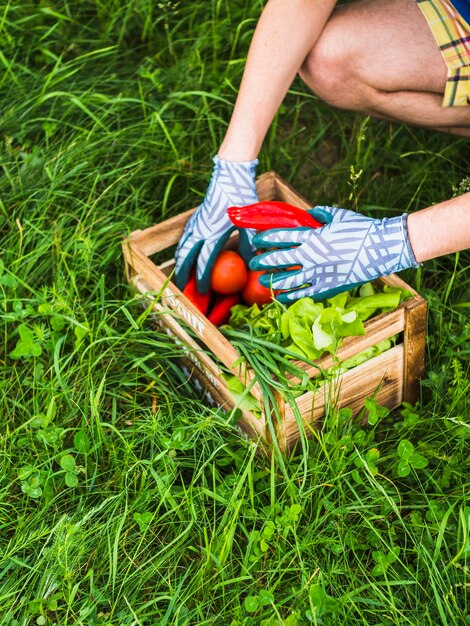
[227,200,323,230]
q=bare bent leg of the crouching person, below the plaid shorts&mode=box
[300,0,470,137]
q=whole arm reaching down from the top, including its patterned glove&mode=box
[175,0,336,293]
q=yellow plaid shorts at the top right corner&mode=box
[417,0,470,106]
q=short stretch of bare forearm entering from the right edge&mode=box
[408,193,470,263]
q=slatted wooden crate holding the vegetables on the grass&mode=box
[123,172,427,450]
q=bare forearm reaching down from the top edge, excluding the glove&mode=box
[218,0,336,161]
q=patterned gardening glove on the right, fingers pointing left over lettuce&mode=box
[250,207,418,303]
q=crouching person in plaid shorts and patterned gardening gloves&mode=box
[175,0,470,302]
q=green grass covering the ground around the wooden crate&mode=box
[0,0,470,626]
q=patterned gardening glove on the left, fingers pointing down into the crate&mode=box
[175,156,258,293]
